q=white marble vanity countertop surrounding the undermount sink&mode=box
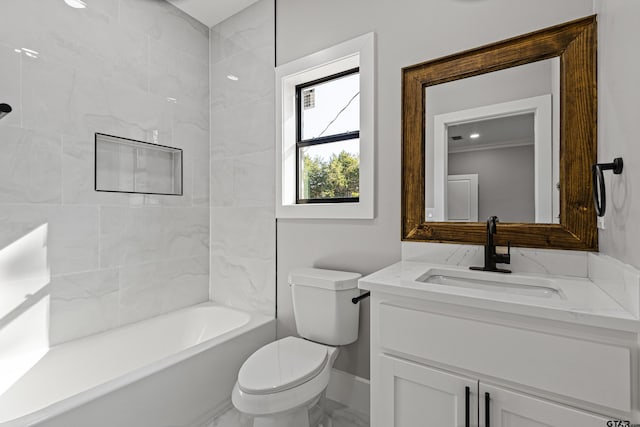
[358,261,640,332]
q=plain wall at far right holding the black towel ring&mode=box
[595,0,640,267]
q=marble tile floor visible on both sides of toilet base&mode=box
[209,399,369,427]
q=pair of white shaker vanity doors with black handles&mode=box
[374,355,611,427]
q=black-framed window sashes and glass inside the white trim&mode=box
[296,68,360,203]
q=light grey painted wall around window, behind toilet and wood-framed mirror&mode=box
[276,0,596,377]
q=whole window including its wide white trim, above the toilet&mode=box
[276,33,375,218]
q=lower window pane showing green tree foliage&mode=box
[298,139,360,200]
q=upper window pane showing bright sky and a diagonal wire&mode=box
[299,73,360,140]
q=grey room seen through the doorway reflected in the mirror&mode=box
[446,113,535,222]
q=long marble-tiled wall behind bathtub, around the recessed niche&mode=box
[0,0,210,345]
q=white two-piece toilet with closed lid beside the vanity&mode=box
[231,268,361,427]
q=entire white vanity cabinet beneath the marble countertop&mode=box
[371,291,637,427]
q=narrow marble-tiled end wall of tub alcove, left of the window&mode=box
[210,0,276,315]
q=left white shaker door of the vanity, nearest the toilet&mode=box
[372,355,478,427]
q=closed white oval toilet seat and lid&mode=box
[238,337,328,394]
